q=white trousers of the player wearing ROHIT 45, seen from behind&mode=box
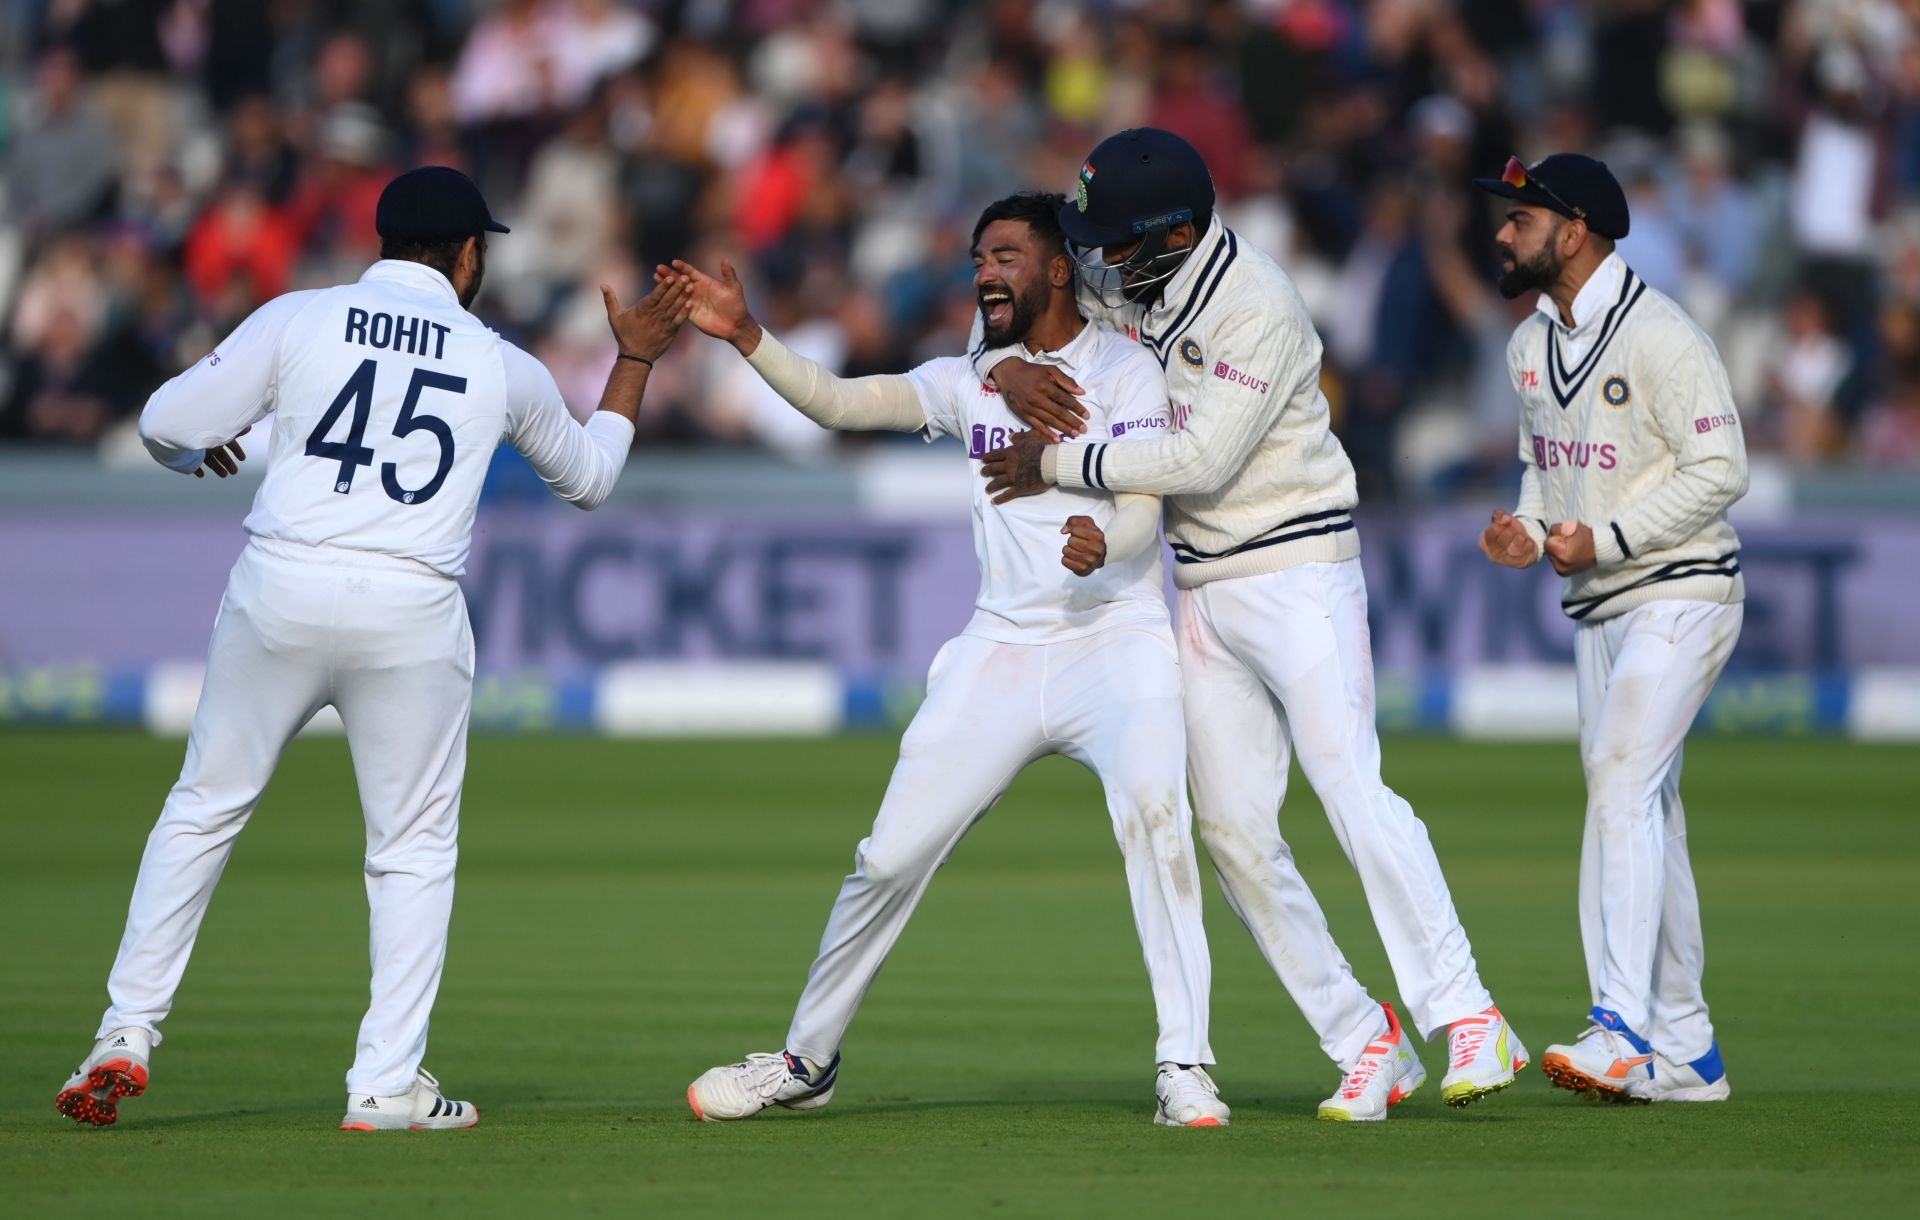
[100,538,472,1097]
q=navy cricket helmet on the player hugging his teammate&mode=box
[1060,127,1213,248]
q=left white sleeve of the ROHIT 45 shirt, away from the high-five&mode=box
[140,290,319,475]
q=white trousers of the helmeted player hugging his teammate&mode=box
[1179,559,1494,1070]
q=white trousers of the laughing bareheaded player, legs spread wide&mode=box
[787,626,1213,1064]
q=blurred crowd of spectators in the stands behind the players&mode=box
[0,0,1920,501]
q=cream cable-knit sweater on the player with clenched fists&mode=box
[1507,254,1747,621]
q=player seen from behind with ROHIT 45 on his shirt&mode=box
[58,167,685,1130]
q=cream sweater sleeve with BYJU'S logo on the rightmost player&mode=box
[1590,332,1747,567]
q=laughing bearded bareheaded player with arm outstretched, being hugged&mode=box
[662,194,1229,1126]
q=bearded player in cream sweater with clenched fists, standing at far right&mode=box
[1475,154,1747,1101]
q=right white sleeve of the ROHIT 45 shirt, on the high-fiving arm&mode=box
[501,342,634,509]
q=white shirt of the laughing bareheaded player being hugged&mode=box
[906,323,1173,644]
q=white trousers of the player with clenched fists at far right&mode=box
[1572,601,1745,1062]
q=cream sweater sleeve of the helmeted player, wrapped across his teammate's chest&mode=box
[1054,309,1290,496]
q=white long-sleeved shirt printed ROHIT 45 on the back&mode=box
[140,259,634,576]
